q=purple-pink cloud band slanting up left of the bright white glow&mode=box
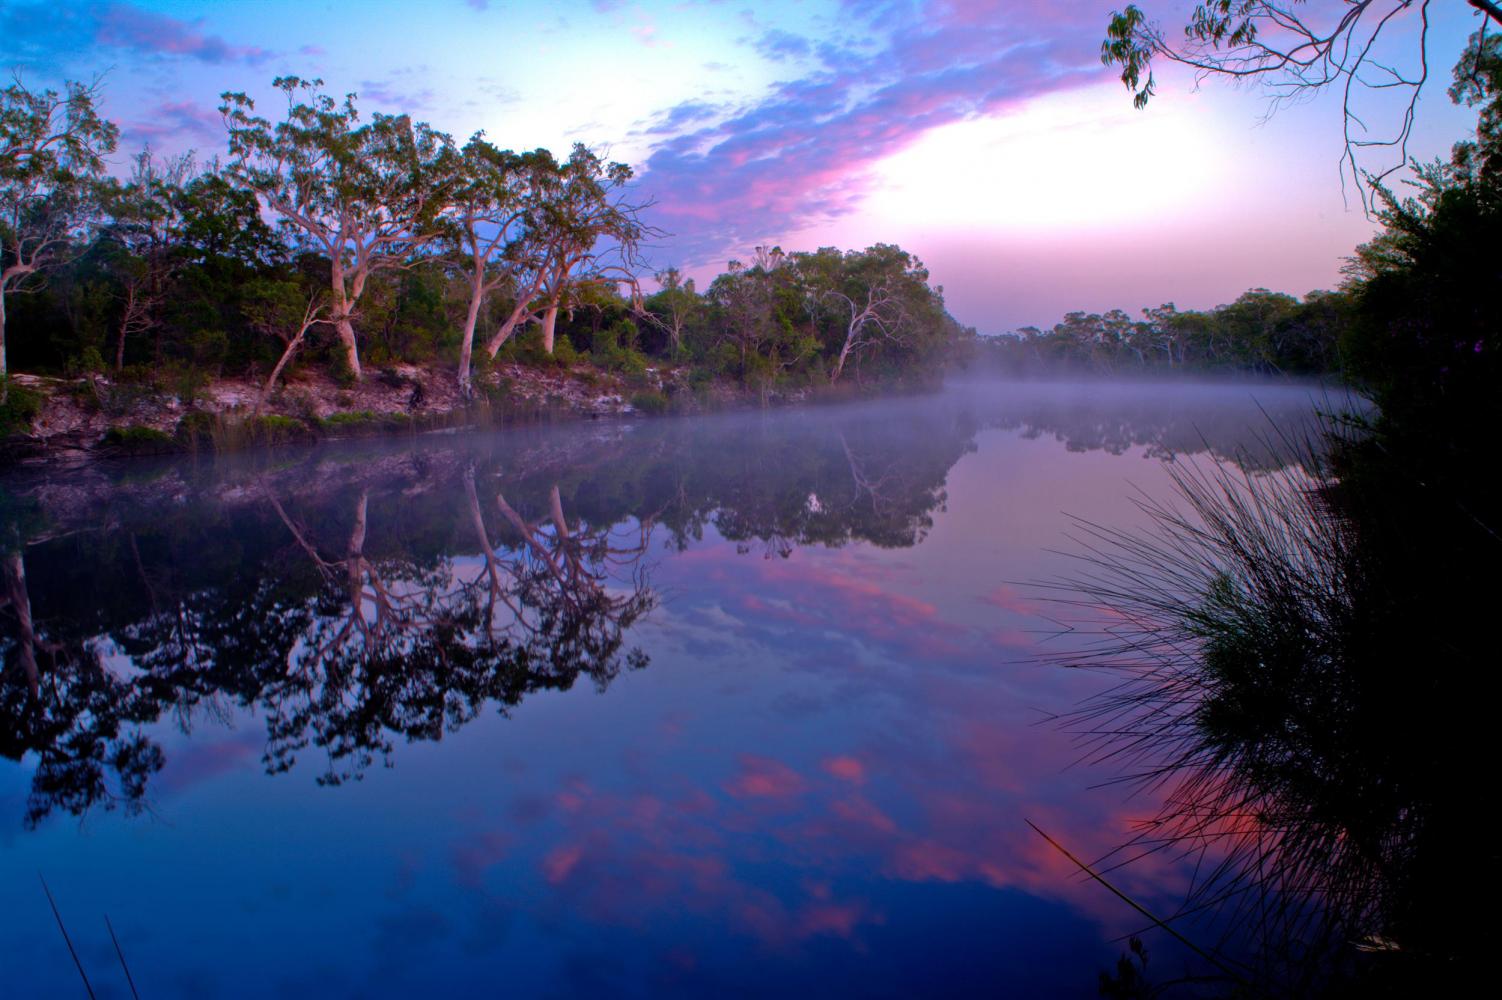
[641,0,1104,264]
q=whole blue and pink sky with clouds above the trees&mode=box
[0,0,1473,332]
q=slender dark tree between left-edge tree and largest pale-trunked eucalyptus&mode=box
[105,149,194,371]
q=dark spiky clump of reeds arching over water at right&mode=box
[1050,420,1431,992]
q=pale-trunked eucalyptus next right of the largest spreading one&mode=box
[445,132,556,396]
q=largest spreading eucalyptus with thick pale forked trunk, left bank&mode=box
[219,77,457,378]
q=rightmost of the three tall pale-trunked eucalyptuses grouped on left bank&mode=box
[510,143,656,357]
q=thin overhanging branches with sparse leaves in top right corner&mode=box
[1101,0,1502,209]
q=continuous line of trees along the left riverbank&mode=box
[0,77,973,414]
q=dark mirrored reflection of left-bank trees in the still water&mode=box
[0,381,1327,823]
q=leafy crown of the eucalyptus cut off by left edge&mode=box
[0,77,119,382]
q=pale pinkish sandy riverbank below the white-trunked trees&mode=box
[0,363,823,468]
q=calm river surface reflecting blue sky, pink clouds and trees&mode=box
[0,384,1325,997]
